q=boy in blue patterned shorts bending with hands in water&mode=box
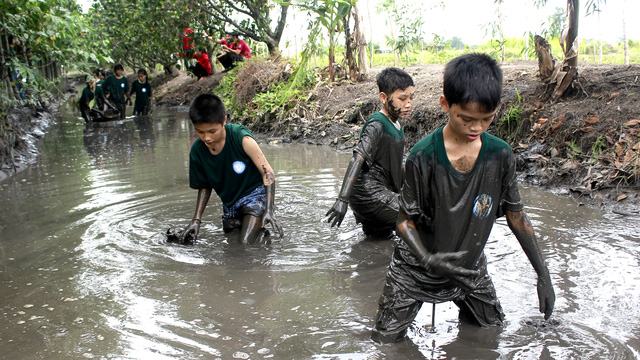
[180,94,283,244]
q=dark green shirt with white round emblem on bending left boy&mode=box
[189,124,263,206]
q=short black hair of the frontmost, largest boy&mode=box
[443,53,502,111]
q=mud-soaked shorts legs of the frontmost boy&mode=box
[371,275,504,343]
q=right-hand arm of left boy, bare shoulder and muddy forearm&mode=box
[242,136,284,237]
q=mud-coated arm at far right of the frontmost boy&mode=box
[506,210,556,319]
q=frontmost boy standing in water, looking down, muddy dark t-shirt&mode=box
[372,54,555,342]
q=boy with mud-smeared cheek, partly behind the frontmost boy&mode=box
[326,68,415,238]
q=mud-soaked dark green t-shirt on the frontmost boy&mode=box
[389,128,523,301]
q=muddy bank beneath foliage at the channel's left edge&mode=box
[0,76,79,181]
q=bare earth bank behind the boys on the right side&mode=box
[156,63,640,210]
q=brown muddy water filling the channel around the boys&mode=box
[0,102,640,359]
